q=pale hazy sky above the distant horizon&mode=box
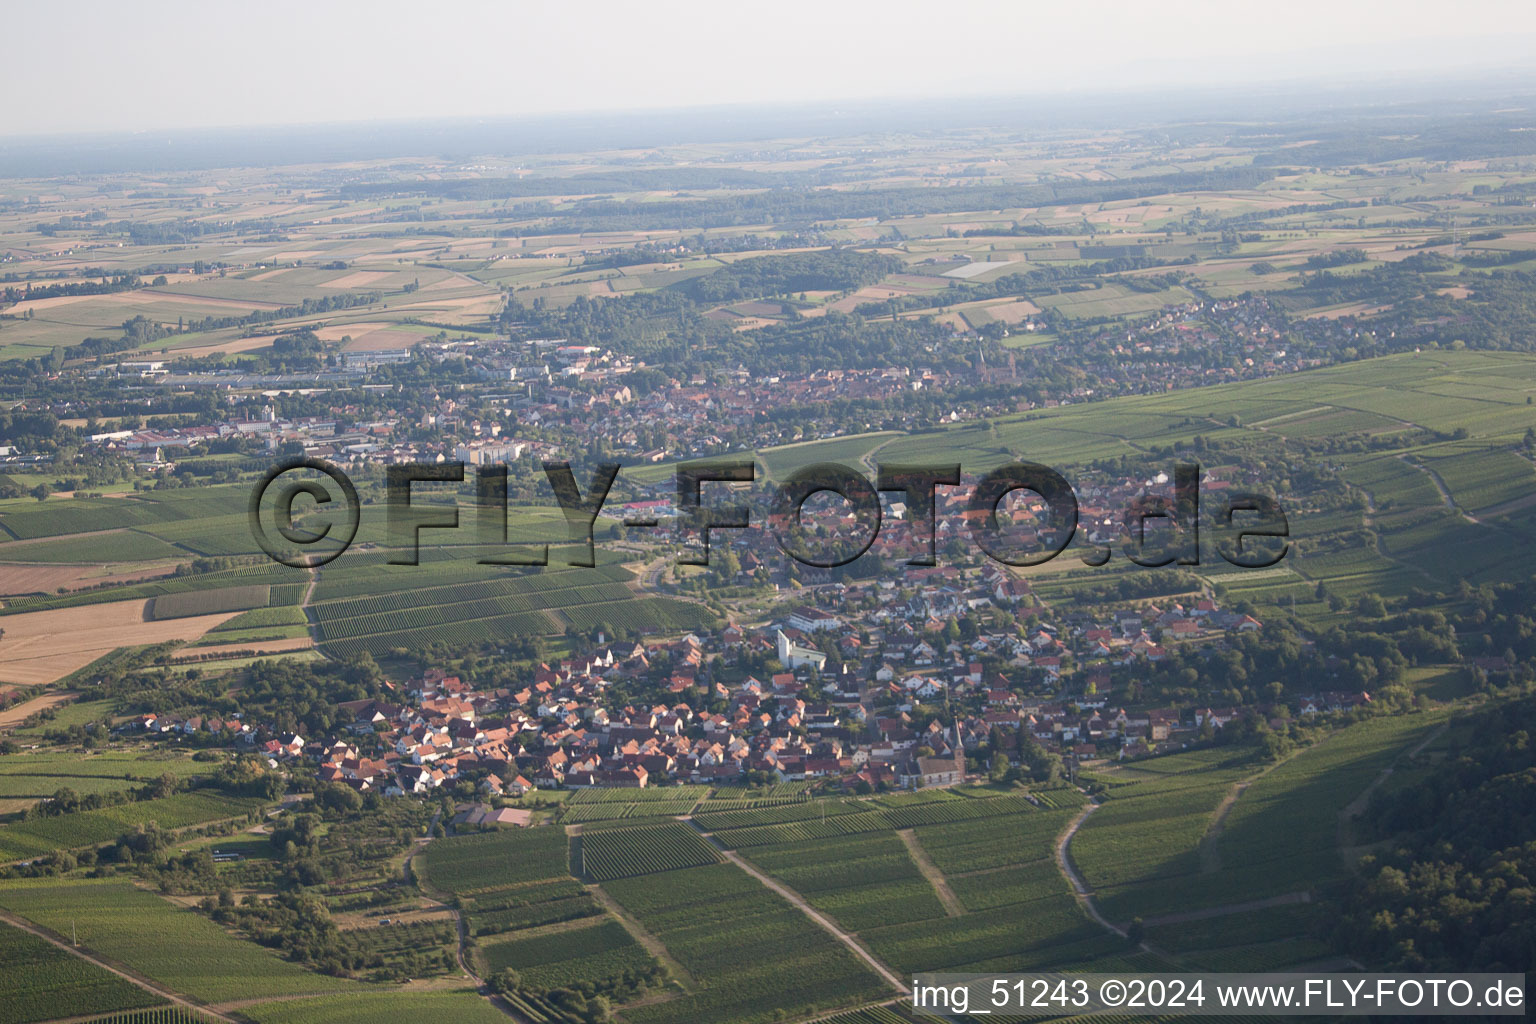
[0,0,1536,135]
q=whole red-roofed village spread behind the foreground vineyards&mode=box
[116,568,1370,824]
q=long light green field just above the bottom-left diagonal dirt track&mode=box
[0,880,358,1003]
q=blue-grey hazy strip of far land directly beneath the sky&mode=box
[9,66,1536,178]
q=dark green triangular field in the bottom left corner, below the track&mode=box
[0,923,164,1024]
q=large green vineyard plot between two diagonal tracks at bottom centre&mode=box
[604,864,889,1024]
